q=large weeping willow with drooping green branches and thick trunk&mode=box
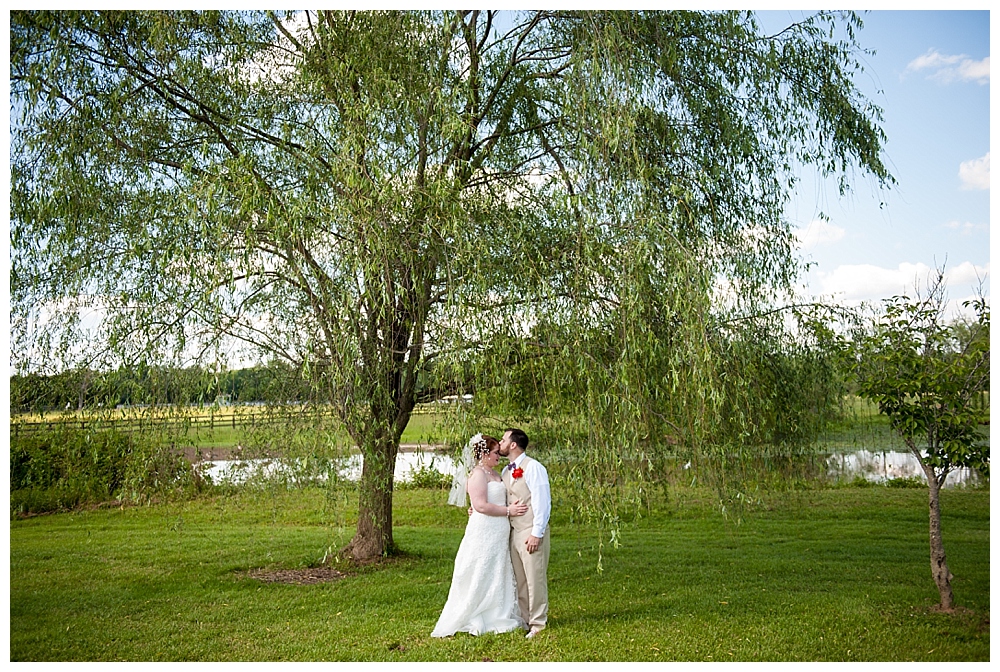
[10,11,891,560]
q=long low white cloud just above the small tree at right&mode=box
[817,261,990,304]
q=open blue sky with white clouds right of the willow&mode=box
[760,10,990,318]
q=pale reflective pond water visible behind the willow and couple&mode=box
[201,450,981,487]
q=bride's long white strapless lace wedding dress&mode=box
[431,481,524,637]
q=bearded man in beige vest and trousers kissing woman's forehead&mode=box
[500,429,552,639]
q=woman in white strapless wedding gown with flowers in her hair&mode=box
[431,434,528,637]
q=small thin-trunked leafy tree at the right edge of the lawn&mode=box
[855,272,990,610]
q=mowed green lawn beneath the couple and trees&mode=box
[10,487,990,661]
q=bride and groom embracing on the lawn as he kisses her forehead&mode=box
[431,429,552,639]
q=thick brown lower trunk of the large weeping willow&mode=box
[341,439,399,563]
